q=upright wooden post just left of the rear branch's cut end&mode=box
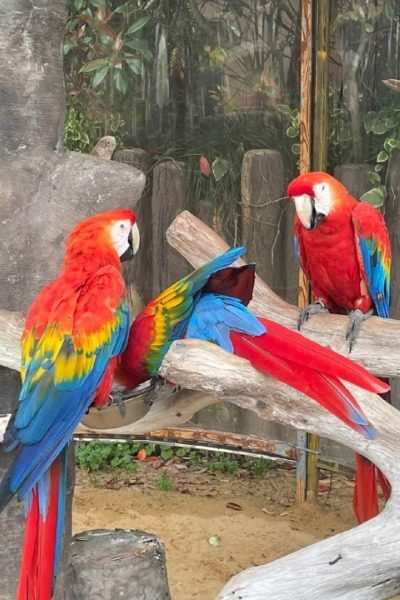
[151,161,188,297]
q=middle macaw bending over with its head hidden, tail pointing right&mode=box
[115,248,388,446]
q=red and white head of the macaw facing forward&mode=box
[288,171,350,229]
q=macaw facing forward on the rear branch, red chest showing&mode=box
[288,172,391,522]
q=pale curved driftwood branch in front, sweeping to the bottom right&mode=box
[161,340,400,600]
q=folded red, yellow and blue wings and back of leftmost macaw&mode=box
[5,267,130,498]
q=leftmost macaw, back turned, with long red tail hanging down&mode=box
[0,210,139,600]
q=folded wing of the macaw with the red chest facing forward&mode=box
[352,202,391,317]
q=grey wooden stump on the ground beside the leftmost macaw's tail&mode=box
[63,529,170,600]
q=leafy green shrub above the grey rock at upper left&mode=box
[63,0,153,152]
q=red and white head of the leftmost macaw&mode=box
[65,209,140,264]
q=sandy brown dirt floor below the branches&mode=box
[73,460,355,600]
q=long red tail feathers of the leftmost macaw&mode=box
[17,460,60,600]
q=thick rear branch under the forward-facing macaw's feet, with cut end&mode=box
[167,211,400,377]
